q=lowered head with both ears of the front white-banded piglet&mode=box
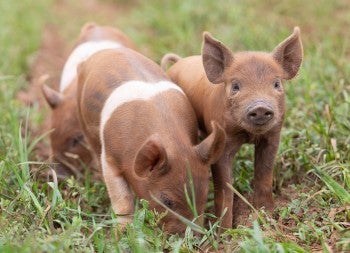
[132,123,226,233]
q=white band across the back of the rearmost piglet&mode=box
[60,40,123,92]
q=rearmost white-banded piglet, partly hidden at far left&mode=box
[42,23,135,179]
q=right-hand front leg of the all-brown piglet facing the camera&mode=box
[253,131,280,211]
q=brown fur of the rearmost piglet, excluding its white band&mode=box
[42,23,135,179]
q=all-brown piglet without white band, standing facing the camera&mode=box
[162,28,303,227]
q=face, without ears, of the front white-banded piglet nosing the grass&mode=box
[145,162,210,234]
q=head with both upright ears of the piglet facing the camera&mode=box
[202,27,303,135]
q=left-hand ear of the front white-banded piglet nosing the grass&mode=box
[134,135,168,178]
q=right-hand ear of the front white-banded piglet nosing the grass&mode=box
[195,121,226,164]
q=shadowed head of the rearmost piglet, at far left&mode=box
[42,85,92,177]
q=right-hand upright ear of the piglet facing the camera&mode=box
[272,27,303,80]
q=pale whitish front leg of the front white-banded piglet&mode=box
[101,154,134,230]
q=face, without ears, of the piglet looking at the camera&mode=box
[225,53,285,134]
